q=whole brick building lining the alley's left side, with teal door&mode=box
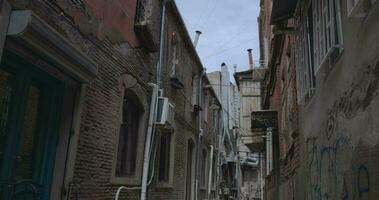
[0,0,223,200]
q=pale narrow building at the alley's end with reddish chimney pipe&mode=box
[234,49,266,199]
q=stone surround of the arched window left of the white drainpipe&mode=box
[110,74,149,185]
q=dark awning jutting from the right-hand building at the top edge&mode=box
[271,0,298,24]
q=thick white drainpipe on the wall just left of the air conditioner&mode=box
[141,83,158,200]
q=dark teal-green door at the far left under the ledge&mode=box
[0,53,64,200]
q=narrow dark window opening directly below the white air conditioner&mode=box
[158,132,171,182]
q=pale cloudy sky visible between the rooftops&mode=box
[176,0,259,75]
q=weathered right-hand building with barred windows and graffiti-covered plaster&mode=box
[260,0,379,199]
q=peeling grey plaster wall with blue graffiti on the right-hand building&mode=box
[298,1,379,200]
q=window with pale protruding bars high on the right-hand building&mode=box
[296,0,342,102]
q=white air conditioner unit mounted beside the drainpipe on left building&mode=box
[155,97,175,126]
